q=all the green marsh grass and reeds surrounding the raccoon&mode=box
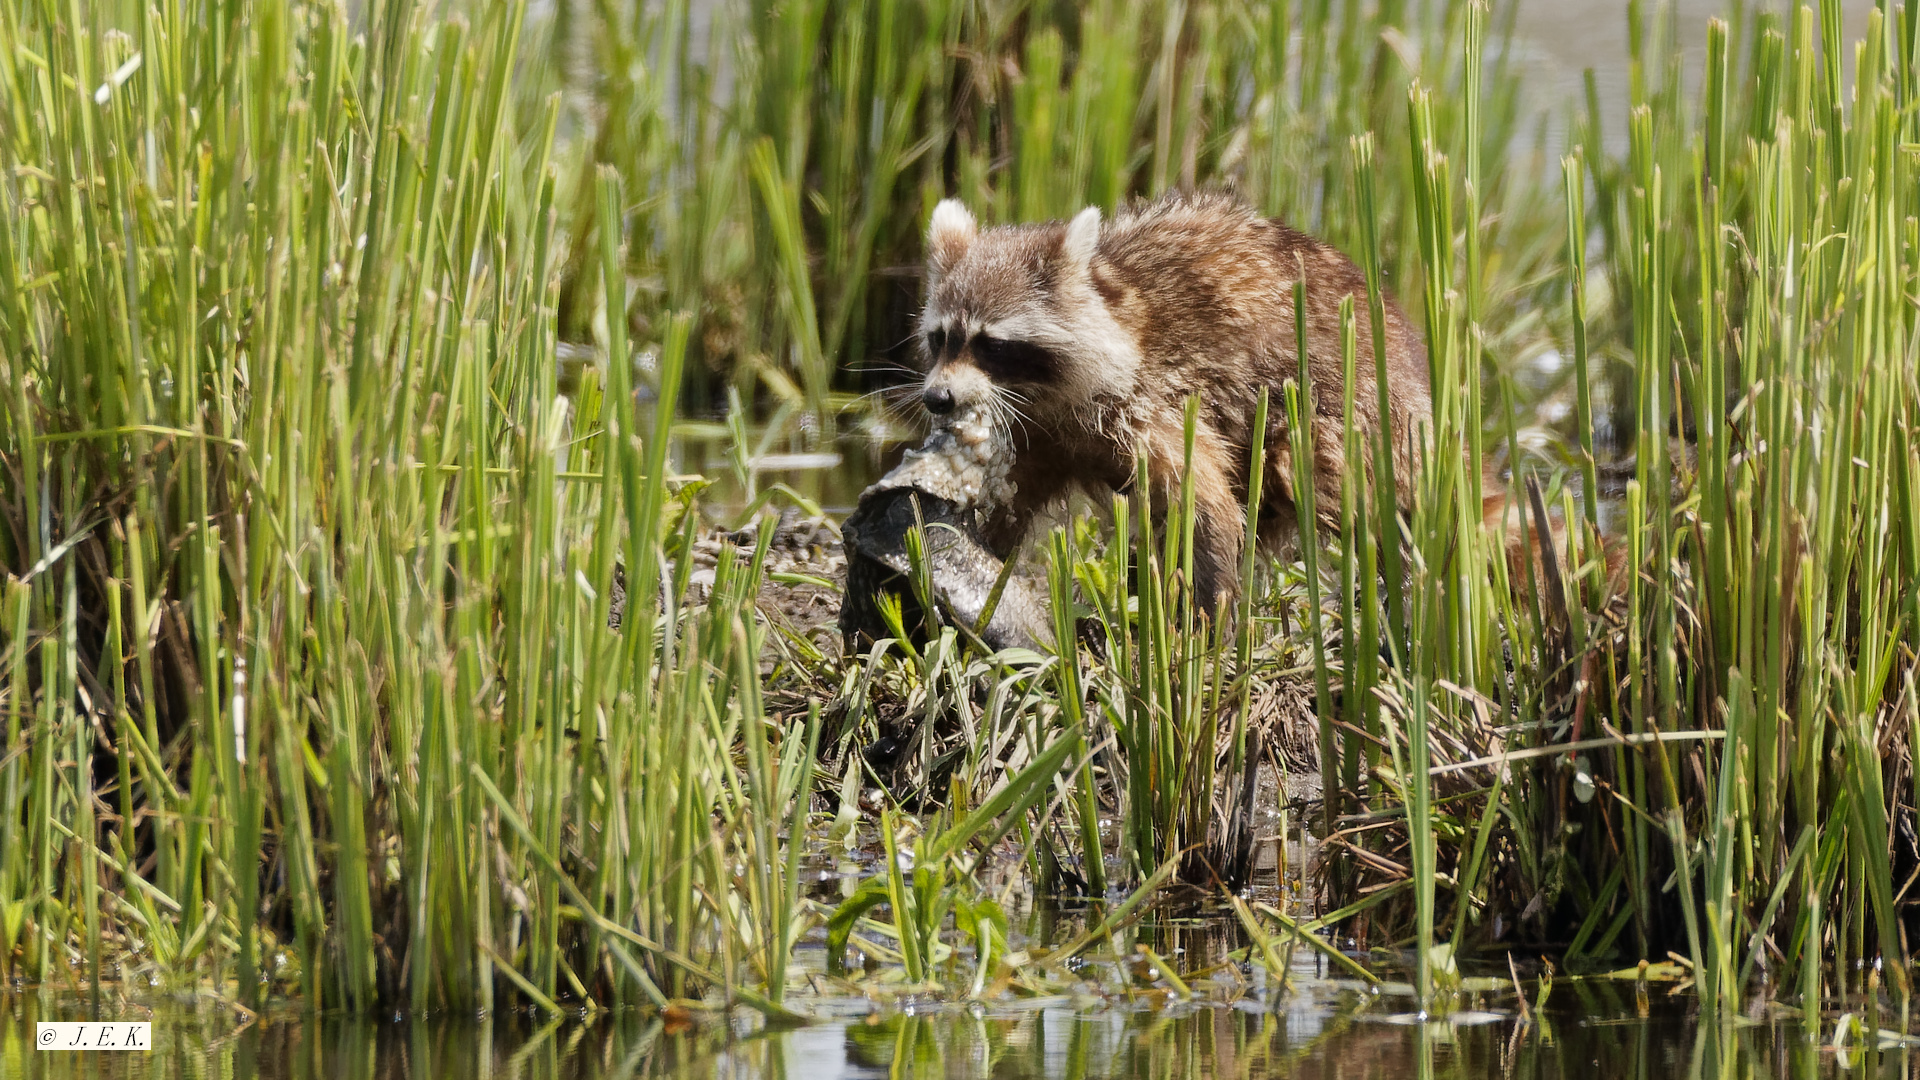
[0,0,1920,1026]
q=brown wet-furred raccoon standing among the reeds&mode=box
[918,192,1430,613]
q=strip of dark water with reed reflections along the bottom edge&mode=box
[0,980,1920,1080]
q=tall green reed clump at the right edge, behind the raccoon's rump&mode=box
[1313,6,1920,1003]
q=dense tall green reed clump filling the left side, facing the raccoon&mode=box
[0,4,812,1013]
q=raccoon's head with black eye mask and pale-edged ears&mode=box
[920,198,1140,423]
